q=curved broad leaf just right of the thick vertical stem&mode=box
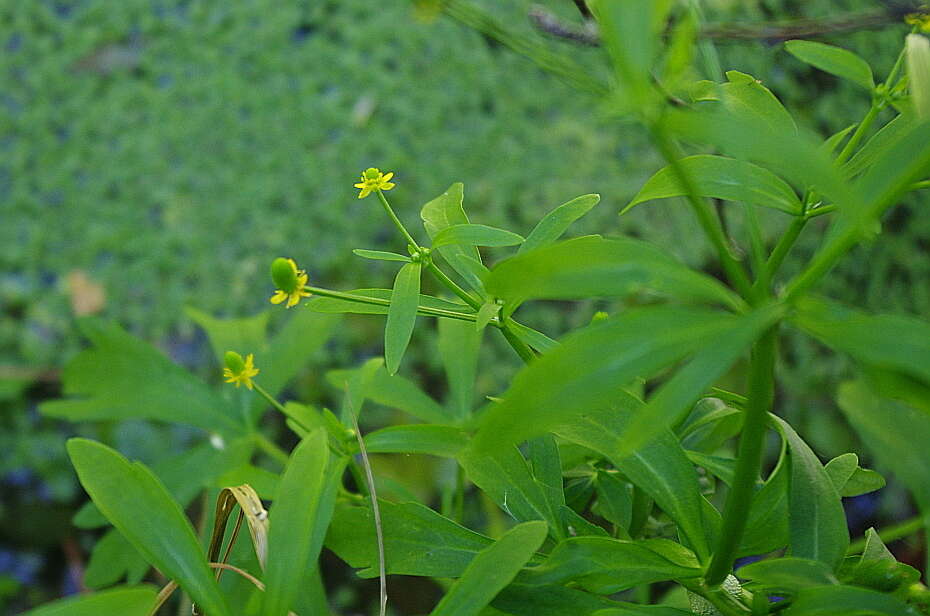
[776,418,849,569]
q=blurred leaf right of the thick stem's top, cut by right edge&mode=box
[792,297,930,383]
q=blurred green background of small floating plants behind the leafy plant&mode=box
[0,0,930,613]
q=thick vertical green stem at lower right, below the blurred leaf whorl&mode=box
[705,327,778,586]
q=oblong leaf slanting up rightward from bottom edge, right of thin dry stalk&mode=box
[431,522,547,616]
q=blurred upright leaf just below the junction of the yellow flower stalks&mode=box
[436,319,481,417]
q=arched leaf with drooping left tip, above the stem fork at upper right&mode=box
[620,154,801,216]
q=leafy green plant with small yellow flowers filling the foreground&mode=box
[25,0,930,616]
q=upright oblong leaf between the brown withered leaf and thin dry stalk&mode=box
[261,428,329,616]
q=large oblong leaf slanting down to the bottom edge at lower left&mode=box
[68,438,231,616]
